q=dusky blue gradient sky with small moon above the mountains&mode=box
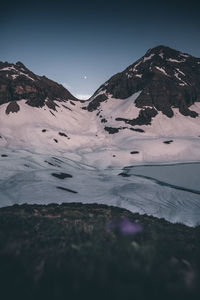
[0,0,200,99]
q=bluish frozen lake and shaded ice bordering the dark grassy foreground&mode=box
[0,149,200,226]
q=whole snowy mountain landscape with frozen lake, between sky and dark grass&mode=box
[0,46,200,225]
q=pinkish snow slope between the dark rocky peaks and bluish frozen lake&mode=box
[0,95,200,169]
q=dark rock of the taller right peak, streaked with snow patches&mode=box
[88,46,200,126]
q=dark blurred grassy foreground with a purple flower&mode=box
[0,203,200,300]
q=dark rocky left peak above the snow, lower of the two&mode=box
[0,62,77,110]
